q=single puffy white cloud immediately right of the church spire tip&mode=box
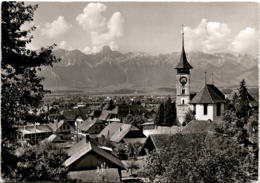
[184,19,231,52]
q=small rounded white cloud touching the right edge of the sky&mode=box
[231,27,258,53]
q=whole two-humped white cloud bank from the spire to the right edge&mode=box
[184,19,258,54]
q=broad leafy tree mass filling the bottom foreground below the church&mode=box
[140,134,253,183]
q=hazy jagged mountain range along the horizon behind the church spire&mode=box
[40,46,258,90]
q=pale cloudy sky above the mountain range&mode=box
[23,2,259,55]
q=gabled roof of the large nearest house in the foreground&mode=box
[64,138,125,169]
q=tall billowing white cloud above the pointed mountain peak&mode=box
[76,3,124,53]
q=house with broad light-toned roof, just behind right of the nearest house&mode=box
[98,122,145,143]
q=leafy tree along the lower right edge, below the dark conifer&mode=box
[216,111,259,179]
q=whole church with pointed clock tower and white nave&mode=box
[175,28,225,124]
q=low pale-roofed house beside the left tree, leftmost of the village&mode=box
[18,124,53,144]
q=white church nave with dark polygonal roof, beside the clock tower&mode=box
[190,84,225,121]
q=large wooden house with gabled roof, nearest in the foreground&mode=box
[64,135,125,175]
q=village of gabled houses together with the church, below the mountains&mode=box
[17,33,258,182]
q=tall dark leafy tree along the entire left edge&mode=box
[1,2,59,178]
